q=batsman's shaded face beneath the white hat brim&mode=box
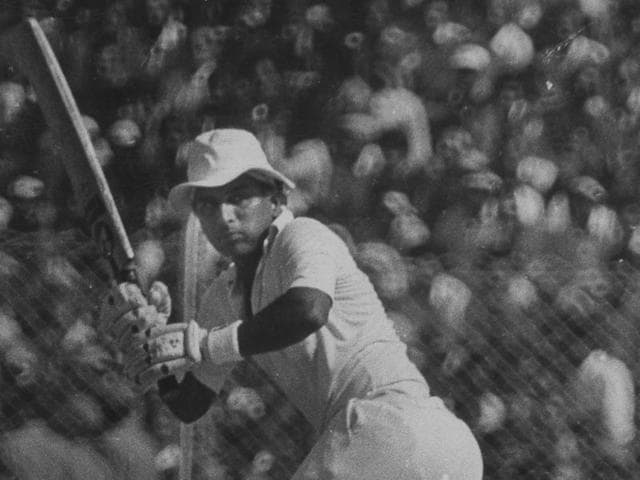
[192,175,279,260]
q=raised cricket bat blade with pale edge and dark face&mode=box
[0,18,137,283]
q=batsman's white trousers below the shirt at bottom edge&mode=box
[292,381,483,480]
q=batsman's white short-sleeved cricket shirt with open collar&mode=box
[194,209,425,430]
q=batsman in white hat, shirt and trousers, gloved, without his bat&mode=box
[101,129,483,480]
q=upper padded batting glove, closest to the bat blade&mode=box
[98,282,171,351]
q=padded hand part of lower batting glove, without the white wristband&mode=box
[125,320,207,390]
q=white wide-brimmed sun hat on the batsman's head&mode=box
[169,128,295,214]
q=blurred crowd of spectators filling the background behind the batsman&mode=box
[0,0,640,480]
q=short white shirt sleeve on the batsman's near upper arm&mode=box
[281,218,347,299]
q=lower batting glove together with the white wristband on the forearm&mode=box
[125,320,242,390]
